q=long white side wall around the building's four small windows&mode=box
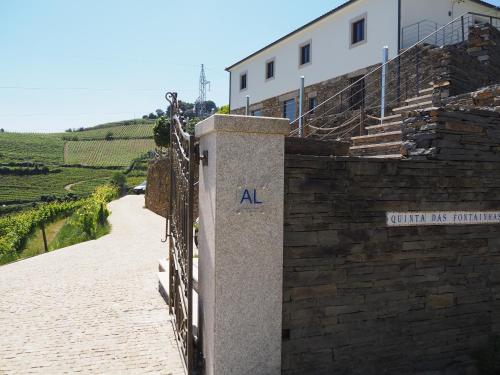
[231,0,398,109]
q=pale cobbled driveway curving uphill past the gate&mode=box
[0,196,184,375]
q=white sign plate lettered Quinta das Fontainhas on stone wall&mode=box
[387,210,500,227]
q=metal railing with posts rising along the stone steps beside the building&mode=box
[290,13,500,139]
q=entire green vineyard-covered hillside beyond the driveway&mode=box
[0,120,155,215]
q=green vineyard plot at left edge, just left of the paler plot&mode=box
[0,133,64,164]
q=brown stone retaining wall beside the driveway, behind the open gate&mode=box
[145,156,170,217]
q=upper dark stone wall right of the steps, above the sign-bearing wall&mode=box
[403,86,500,161]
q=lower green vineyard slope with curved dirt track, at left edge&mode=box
[0,168,115,206]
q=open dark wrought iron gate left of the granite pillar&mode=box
[165,93,201,375]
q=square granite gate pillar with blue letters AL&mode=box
[196,115,290,375]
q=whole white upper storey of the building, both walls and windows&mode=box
[226,0,500,111]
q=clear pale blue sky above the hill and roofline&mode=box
[0,0,343,132]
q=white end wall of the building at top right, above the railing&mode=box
[401,0,500,27]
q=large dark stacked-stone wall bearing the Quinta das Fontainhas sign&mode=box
[282,153,500,375]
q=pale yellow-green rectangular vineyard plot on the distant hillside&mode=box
[65,139,155,167]
